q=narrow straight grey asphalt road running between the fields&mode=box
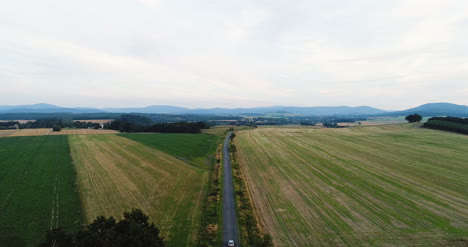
[223,132,240,247]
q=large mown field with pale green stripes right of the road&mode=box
[238,124,468,246]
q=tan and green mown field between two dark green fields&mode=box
[69,135,208,246]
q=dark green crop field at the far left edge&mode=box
[0,136,82,246]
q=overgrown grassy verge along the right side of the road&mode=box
[229,133,273,247]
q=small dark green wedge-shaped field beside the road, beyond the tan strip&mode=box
[120,133,220,168]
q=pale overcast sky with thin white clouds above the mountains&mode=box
[0,0,468,110]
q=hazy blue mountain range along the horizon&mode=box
[0,103,468,116]
